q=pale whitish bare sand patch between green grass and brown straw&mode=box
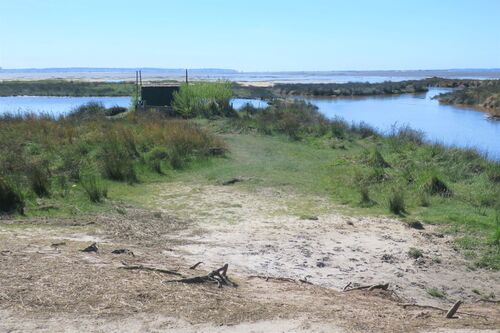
[152,183,500,304]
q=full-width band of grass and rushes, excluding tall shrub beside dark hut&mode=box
[0,92,500,270]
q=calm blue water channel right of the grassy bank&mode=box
[307,88,500,160]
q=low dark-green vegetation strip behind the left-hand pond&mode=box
[0,80,134,97]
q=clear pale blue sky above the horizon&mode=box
[0,0,500,71]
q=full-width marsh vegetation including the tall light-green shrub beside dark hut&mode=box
[0,82,500,269]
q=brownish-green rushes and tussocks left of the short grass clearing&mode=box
[0,112,225,212]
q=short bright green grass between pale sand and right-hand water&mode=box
[168,120,500,269]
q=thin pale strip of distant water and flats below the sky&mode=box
[0,68,500,85]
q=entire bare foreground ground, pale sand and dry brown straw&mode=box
[0,183,500,332]
